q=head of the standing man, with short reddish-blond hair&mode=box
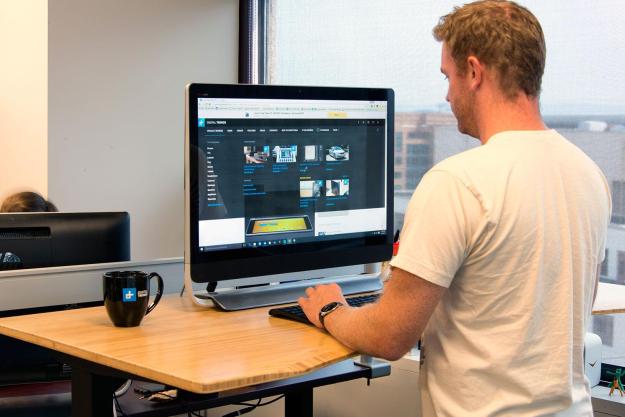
[433,0,546,138]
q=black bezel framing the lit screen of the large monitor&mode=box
[185,84,394,282]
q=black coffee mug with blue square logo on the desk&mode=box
[102,271,163,327]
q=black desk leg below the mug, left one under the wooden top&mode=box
[72,367,119,417]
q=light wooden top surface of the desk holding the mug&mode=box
[0,295,354,393]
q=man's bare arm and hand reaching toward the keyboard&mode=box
[299,268,446,360]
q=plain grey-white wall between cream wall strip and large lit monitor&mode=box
[48,0,238,260]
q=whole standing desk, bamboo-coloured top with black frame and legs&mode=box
[0,295,386,417]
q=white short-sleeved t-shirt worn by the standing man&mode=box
[391,130,611,417]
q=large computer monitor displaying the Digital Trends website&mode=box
[185,84,394,309]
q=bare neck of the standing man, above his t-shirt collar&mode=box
[477,94,547,145]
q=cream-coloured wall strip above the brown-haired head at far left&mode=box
[0,0,48,202]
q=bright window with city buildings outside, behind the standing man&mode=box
[267,0,625,365]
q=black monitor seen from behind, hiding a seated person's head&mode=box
[0,212,130,269]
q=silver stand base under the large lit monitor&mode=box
[184,273,382,311]
